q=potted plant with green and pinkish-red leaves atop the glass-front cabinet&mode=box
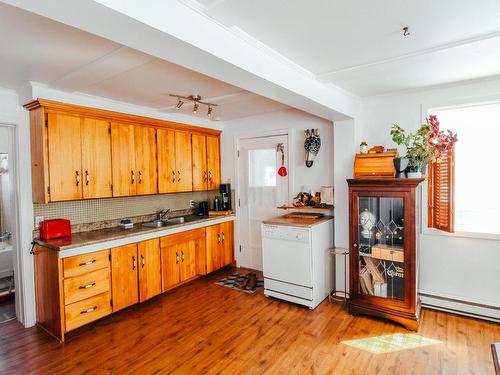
[391,115,457,178]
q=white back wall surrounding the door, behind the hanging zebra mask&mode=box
[221,110,333,199]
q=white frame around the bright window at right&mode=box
[420,94,500,240]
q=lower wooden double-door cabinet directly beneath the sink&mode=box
[160,228,205,291]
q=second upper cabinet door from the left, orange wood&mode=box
[81,118,112,198]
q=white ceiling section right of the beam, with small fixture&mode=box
[188,0,500,96]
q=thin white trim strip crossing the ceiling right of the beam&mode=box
[316,30,500,82]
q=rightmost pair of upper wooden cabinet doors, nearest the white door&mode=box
[192,134,220,191]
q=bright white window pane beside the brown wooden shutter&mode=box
[432,103,500,234]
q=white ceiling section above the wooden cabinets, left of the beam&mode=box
[0,4,289,120]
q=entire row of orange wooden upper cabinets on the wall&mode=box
[25,99,220,203]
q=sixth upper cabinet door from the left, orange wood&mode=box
[175,132,193,191]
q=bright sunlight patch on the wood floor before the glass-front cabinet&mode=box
[342,333,441,354]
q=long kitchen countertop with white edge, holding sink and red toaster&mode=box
[35,215,235,258]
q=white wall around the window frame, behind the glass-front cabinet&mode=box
[344,80,500,318]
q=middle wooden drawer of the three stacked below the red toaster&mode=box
[64,268,109,305]
